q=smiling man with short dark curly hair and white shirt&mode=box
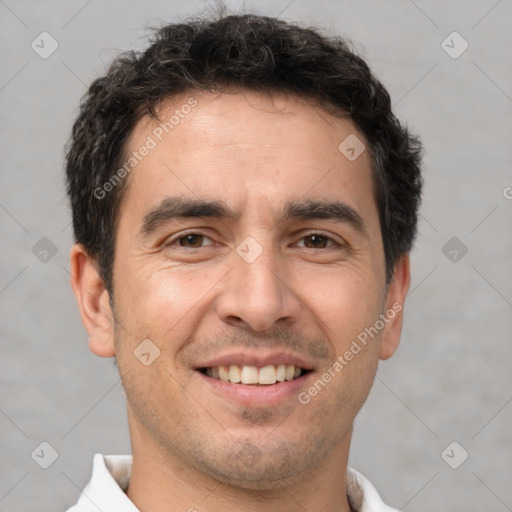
[67,15,421,512]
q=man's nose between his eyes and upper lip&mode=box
[217,244,301,331]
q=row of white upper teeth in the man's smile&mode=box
[206,364,301,384]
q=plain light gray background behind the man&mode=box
[0,0,512,512]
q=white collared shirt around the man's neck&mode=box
[67,453,398,512]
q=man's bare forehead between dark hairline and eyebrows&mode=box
[121,91,375,226]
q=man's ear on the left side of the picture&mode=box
[70,244,115,357]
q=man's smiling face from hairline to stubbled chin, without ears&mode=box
[101,92,404,489]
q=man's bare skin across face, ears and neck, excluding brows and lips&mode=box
[71,91,409,512]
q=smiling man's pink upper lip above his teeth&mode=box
[196,350,313,370]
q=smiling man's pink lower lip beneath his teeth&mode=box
[195,371,313,406]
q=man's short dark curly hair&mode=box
[66,14,422,297]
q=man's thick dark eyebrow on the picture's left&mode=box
[140,197,237,236]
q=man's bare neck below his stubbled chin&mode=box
[126,418,351,512]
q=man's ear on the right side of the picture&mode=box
[380,254,411,360]
